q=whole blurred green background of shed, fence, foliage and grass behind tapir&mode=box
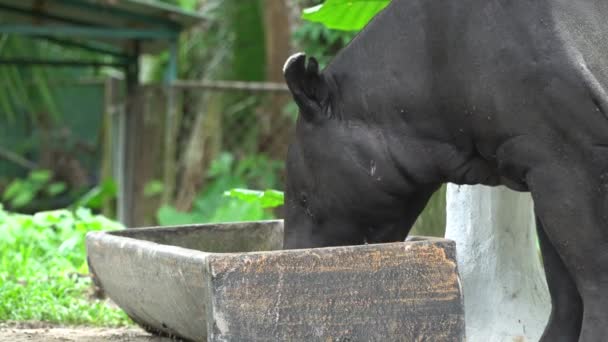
[0,0,445,328]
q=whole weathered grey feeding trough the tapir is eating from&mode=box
[87,221,464,341]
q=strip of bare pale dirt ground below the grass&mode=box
[0,322,176,342]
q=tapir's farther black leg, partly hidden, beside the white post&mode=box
[536,218,583,342]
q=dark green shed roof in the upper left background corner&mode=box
[0,0,203,52]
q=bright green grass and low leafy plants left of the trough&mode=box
[0,205,132,326]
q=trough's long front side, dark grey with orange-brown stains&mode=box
[207,239,464,341]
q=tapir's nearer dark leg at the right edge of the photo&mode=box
[526,164,608,342]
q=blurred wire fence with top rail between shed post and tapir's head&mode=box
[106,81,296,226]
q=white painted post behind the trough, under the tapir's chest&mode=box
[446,184,551,342]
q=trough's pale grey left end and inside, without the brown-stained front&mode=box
[87,221,283,341]
